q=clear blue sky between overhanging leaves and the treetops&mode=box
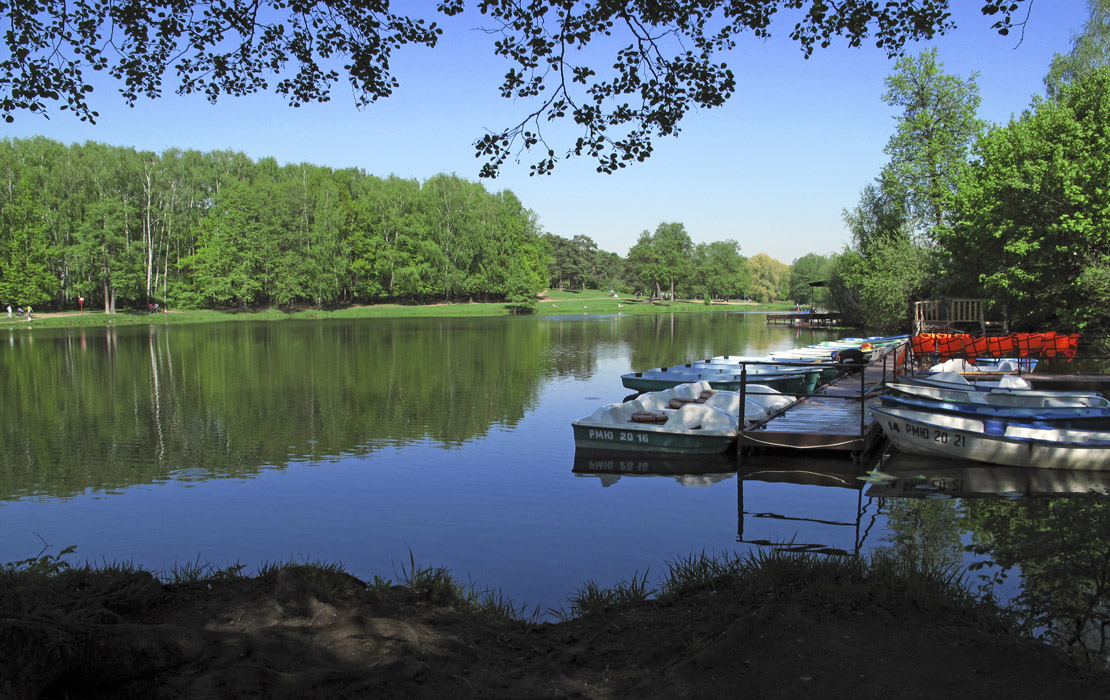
[0,0,1087,263]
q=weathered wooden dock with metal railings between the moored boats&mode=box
[738,344,908,459]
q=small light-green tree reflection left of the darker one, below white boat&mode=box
[886,498,963,571]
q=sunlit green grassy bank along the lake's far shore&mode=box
[0,290,794,328]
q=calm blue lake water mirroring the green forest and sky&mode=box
[0,313,1104,607]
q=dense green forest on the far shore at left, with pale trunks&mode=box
[0,139,549,312]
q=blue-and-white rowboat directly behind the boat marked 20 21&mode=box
[879,394,1110,430]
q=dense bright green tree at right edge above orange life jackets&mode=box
[939,67,1110,332]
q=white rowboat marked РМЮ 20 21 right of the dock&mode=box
[868,405,1110,469]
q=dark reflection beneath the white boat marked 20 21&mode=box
[865,449,1110,499]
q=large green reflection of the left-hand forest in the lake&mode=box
[0,319,548,499]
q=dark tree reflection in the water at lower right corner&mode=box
[968,495,1110,666]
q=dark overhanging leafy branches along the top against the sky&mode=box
[0,0,1026,176]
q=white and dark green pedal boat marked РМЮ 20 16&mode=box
[571,382,794,455]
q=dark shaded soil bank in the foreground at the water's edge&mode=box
[0,567,1110,700]
